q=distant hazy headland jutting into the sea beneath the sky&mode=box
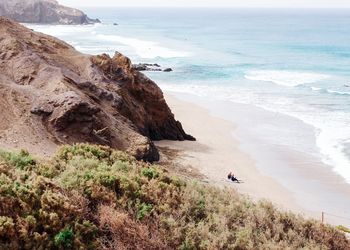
[0,0,100,24]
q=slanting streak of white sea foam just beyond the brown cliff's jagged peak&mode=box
[96,34,190,58]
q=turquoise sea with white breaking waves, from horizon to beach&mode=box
[31,9,350,182]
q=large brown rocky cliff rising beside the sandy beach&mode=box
[0,17,194,161]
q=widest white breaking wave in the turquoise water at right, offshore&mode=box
[244,70,329,87]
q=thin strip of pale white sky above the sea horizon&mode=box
[58,0,350,8]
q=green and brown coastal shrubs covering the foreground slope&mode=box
[0,144,350,250]
